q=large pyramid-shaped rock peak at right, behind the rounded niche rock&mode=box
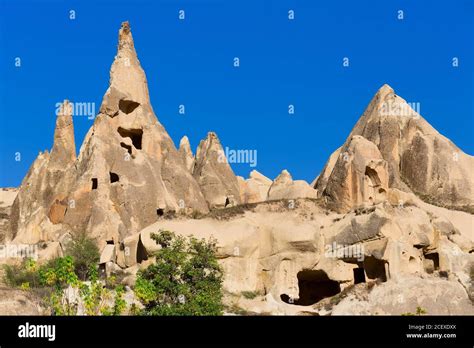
[315,85,474,211]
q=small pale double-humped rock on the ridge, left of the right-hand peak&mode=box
[268,169,317,200]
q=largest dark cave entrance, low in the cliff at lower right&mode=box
[280,270,341,306]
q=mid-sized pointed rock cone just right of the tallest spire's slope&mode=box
[193,132,240,207]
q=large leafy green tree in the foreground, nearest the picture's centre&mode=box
[134,231,223,315]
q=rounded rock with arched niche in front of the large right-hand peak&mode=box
[321,135,388,211]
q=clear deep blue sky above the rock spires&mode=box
[0,0,474,187]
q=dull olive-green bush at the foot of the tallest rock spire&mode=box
[65,233,100,280]
